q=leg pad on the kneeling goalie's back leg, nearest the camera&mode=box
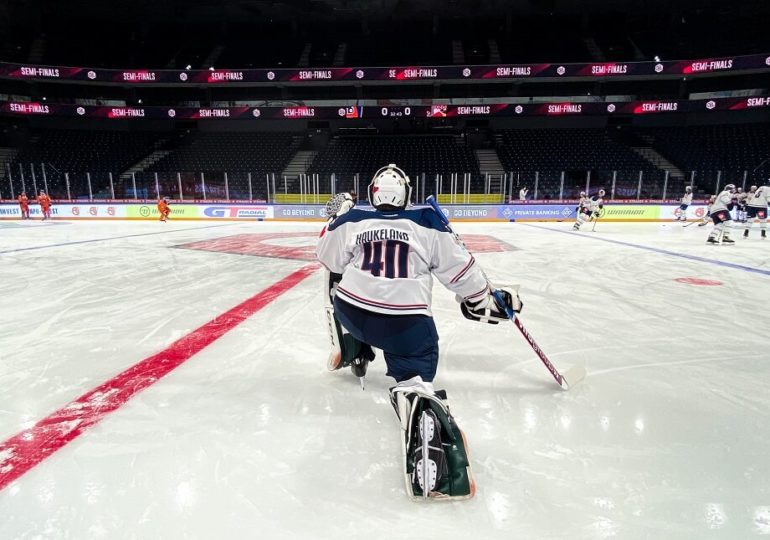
[391,377,476,500]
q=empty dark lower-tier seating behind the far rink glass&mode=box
[10,124,770,198]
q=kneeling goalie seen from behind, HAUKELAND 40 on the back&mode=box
[316,164,521,499]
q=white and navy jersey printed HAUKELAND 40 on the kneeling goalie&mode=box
[316,208,489,315]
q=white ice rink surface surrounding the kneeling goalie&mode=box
[0,217,770,540]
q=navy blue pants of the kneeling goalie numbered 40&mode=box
[334,298,438,382]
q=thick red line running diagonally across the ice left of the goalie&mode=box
[0,263,319,490]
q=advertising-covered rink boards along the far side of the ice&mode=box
[0,201,706,222]
